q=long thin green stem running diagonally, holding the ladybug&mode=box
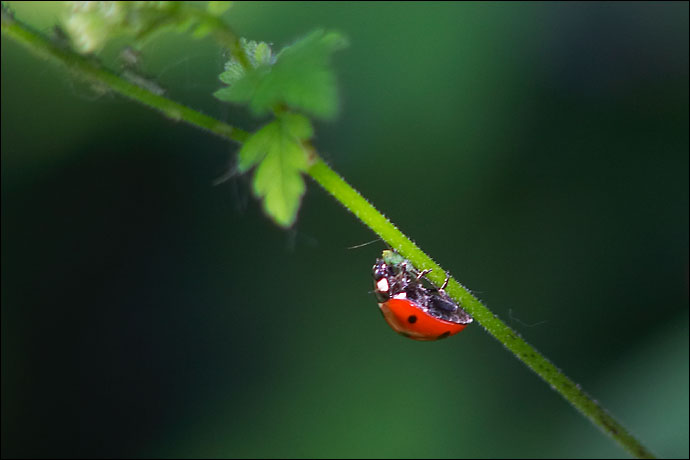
[2,14,653,458]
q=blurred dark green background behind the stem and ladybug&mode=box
[1,2,689,458]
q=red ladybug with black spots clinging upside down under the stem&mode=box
[373,250,472,340]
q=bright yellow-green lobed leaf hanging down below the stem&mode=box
[238,114,313,227]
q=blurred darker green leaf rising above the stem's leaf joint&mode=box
[215,30,347,118]
